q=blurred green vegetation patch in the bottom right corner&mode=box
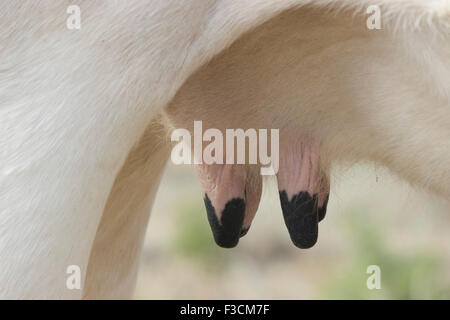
[318,209,450,299]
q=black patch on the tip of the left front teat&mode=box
[203,194,245,248]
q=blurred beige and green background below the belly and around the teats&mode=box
[135,165,450,299]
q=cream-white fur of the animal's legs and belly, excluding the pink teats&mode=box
[0,0,450,298]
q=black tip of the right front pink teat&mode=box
[280,190,319,249]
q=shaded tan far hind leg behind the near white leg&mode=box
[83,121,170,299]
